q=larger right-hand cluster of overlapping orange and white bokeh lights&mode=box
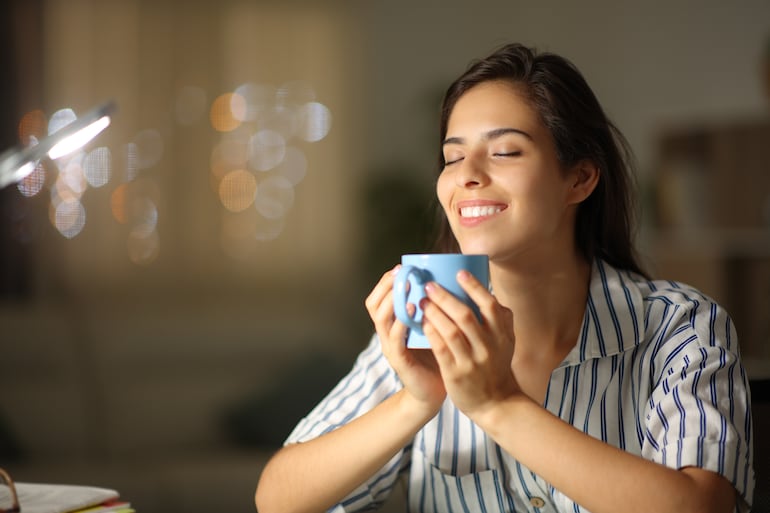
[210,80,332,250]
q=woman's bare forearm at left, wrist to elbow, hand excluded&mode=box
[256,389,428,513]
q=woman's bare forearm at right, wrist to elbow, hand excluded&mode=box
[474,394,735,513]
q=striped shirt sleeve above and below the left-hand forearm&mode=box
[284,335,411,513]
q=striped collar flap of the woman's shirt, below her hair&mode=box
[560,259,644,367]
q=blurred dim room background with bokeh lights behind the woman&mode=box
[0,0,770,513]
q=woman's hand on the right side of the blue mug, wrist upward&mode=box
[420,271,521,418]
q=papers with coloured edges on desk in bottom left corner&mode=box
[0,483,135,513]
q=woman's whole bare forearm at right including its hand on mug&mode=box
[423,278,736,513]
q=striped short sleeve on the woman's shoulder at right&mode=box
[642,298,755,512]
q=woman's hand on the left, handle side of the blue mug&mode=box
[365,265,446,418]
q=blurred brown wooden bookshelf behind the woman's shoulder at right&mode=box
[649,116,770,368]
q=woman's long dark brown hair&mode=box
[436,44,646,275]
